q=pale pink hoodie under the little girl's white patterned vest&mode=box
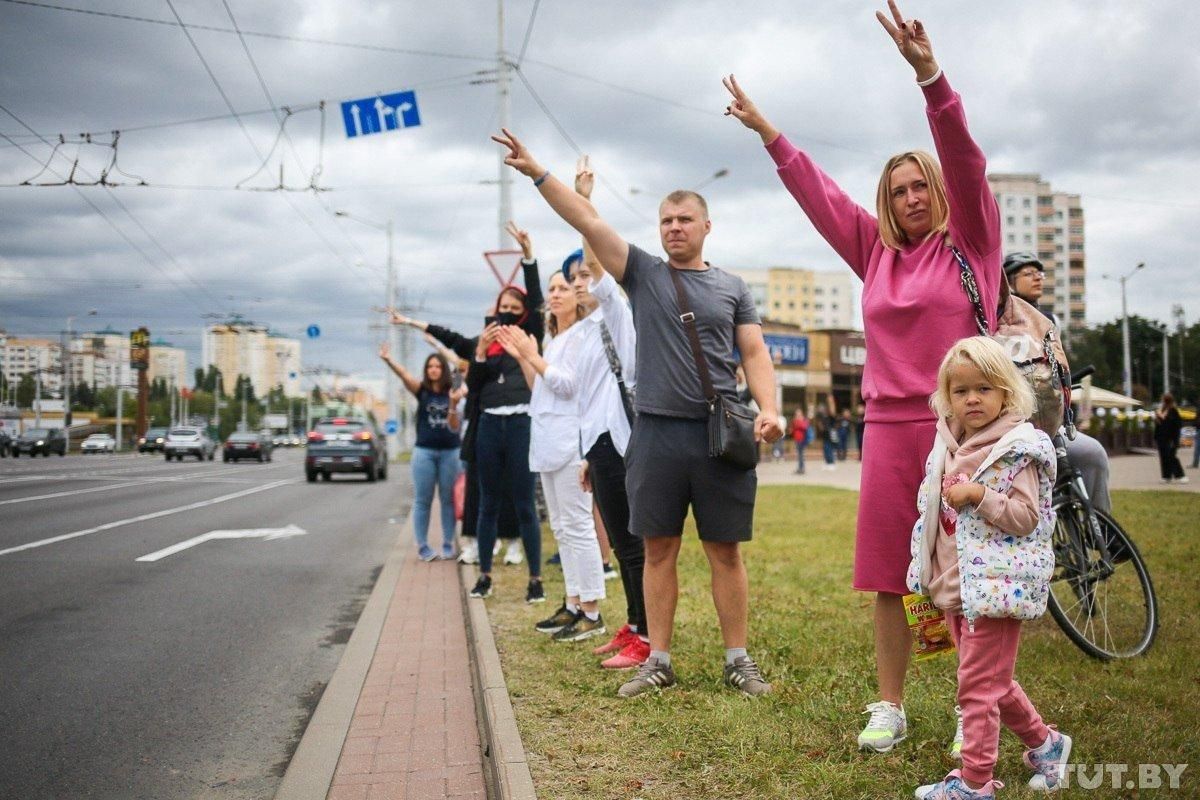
[929,414,1039,614]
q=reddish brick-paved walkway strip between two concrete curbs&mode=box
[329,547,486,800]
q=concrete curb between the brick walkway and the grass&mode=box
[458,564,538,800]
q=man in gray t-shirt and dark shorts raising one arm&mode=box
[492,131,782,697]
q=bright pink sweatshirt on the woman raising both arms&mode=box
[767,74,1002,422]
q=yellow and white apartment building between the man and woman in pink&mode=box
[731,266,854,331]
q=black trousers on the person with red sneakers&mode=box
[587,433,647,636]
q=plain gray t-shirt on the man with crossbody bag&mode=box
[622,245,760,419]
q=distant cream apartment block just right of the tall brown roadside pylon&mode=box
[200,320,301,397]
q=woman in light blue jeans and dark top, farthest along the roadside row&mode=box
[379,344,463,561]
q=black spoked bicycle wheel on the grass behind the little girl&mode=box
[1049,499,1158,661]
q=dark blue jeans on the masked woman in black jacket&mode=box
[475,413,541,578]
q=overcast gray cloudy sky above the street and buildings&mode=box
[0,0,1200,391]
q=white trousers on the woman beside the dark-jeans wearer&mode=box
[539,461,605,602]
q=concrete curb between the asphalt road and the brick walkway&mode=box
[275,516,413,800]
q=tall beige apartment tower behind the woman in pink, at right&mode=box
[988,173,1087,339]
